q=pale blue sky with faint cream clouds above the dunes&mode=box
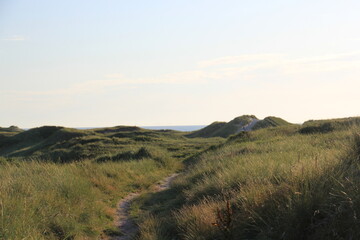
[0,0,360,128]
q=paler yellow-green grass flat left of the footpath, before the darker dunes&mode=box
[0,155,180,239]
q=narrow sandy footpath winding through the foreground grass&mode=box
[112,173,179,240]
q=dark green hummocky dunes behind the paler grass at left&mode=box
[0,126,222,162]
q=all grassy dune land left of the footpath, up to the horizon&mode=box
[0,126,221,239]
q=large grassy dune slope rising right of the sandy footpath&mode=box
[133,119,360,240]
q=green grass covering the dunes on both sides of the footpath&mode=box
[0,116,360,240]
